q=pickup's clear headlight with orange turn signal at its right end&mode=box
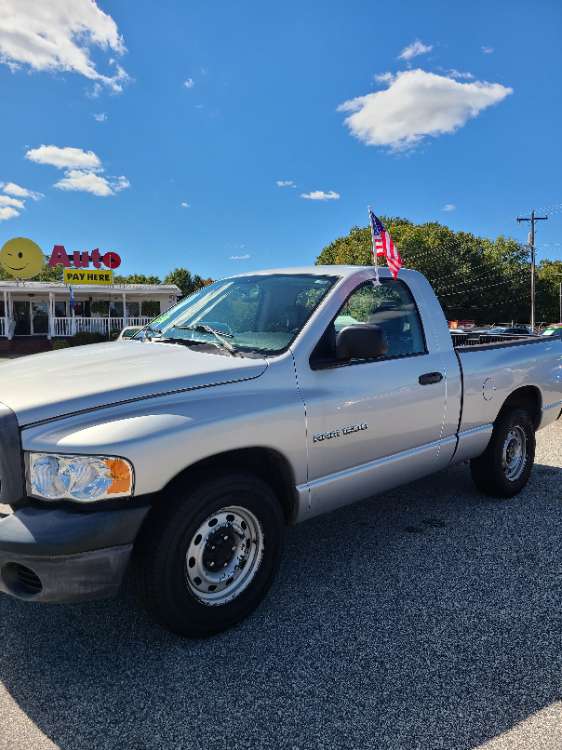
[27,453,134,503]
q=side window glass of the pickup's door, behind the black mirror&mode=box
[313,279,426,363]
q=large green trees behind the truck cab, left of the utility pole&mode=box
[316,217,529,322]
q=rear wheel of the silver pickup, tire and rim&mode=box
[470,407,536,497]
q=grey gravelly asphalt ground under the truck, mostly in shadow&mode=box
[0,423,562,750]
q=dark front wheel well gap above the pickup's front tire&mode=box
[163,447,297,523]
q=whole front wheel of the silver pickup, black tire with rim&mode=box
[141,474,284,637]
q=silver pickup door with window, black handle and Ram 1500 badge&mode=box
[296,278,455,515]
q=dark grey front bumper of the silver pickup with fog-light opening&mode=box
[0,507,149,602]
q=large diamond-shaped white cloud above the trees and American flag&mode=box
[338,68,513,151]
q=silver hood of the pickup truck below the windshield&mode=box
[0,341,267,426]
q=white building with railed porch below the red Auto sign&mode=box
[0,279,181,340]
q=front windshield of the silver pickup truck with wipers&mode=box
[140,274,337,354]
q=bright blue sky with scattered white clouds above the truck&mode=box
[0,0,562,277]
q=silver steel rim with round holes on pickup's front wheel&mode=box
[185,505,264,606]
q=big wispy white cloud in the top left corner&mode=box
[0,0,128,92]
